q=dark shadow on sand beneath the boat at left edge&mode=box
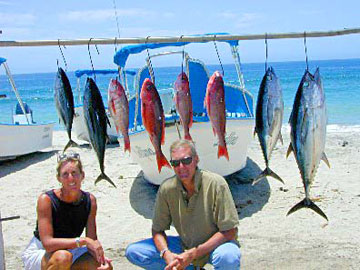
[0,150,58,178]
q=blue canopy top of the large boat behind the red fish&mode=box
[114,33,239,68]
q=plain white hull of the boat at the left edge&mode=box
[0,123,55,160]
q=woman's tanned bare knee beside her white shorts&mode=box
[41,250,72,270]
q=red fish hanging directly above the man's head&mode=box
[174,72,193,141]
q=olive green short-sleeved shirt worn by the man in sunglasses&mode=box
[152,169,239,266]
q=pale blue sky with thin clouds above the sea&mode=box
[0,0,360,73]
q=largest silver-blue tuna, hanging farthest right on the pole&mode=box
[287,68,330,220]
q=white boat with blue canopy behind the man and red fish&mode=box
[74,34,254,185]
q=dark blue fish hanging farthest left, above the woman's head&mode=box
[54,67,78,152]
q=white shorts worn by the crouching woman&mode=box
[21,236,87,270]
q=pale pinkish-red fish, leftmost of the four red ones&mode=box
[108,79,131,152]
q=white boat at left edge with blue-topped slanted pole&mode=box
[0,57,55,160]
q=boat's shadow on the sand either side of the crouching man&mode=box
[130,158,270,219]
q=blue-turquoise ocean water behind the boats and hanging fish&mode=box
[0,59,360,129]
